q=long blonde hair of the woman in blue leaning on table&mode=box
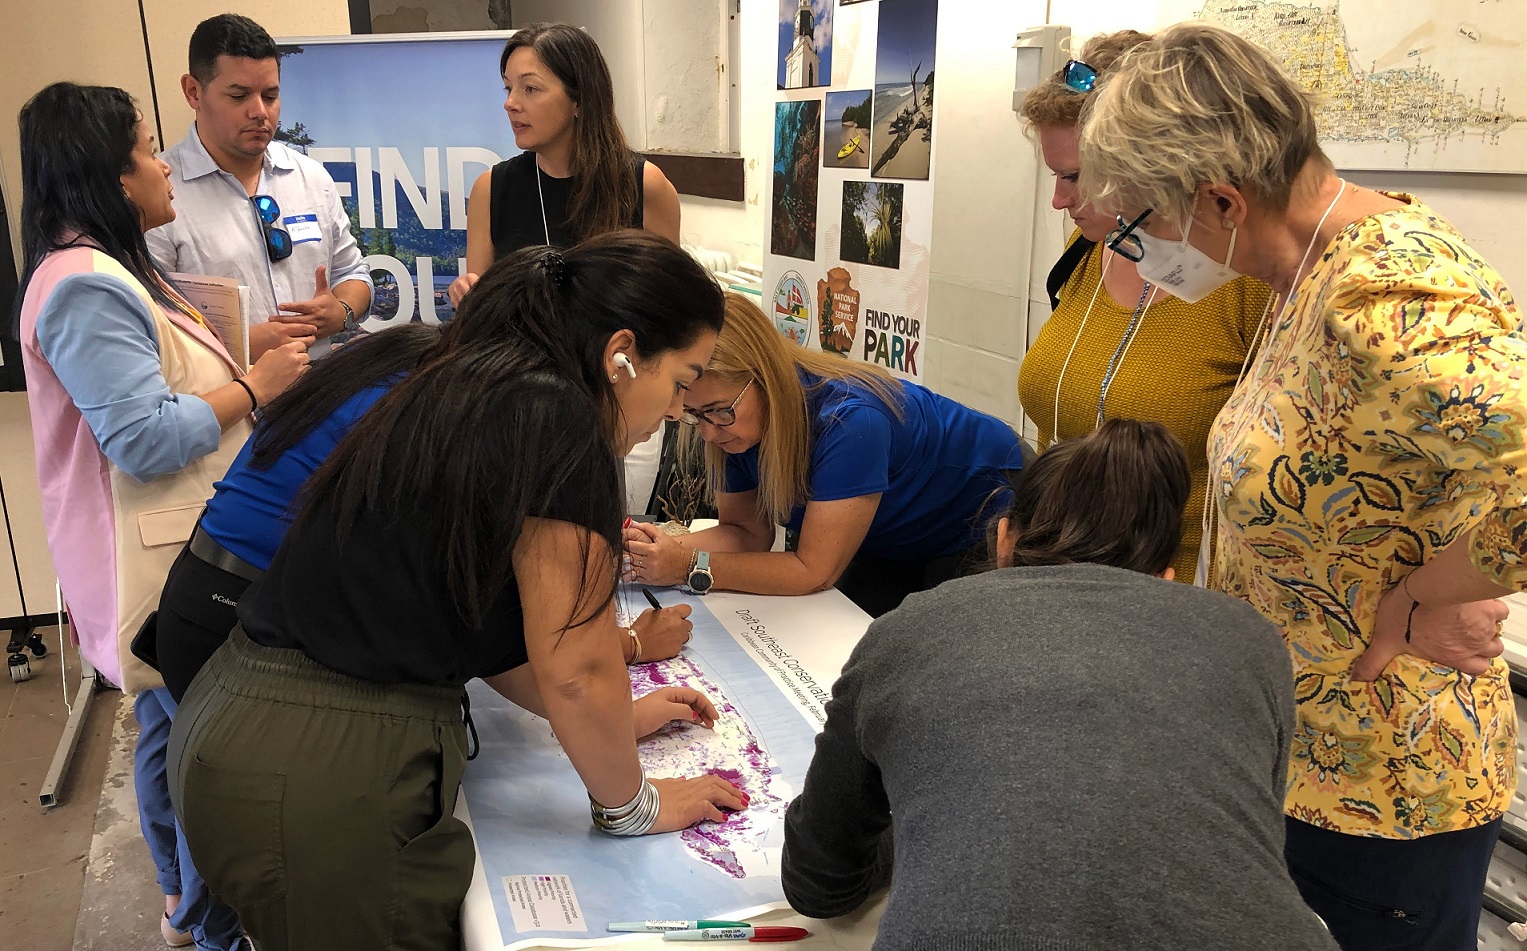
[705,293,902,525]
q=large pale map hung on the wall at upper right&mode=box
[1162,0,1527,172]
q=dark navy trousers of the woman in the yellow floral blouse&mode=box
[1283,818,1501,951]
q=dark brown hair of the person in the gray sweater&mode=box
[993,420,1193,574]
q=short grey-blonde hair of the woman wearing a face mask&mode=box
[1078,23,1330,229]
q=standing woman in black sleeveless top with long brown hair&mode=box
[449,23,680,305]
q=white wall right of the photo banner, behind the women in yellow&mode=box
[925,0,1527,423]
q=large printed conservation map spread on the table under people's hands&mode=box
[461,591,863,948]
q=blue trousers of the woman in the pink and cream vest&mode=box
[133,687,243,951]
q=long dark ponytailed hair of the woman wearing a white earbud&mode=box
[296,230,722,627]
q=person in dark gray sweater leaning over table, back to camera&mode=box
[782,420,1336,951]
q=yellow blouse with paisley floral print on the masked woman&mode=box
[1209,195,1527,840]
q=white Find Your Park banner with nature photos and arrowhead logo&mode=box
[764,0,938,380]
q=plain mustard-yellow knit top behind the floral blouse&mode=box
[1019,232,1272,583]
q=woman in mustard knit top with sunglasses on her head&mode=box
[1019,31,1272,582]
